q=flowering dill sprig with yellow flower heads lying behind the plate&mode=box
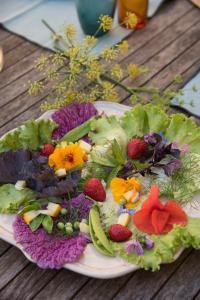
[29,18,198,110]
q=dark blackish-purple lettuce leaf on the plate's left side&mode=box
[0,149,80,198]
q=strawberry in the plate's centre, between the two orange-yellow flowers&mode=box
[83,178,106,202]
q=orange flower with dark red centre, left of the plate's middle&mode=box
[49,144,87,170]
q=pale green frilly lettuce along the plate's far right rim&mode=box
[121,104,200,154]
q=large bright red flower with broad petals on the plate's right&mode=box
[133,185,188,234]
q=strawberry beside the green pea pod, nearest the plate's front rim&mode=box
[109,224,132,242]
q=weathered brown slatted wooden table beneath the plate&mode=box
[0,0,200,300]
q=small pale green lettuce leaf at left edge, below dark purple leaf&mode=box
[0,184,35,213]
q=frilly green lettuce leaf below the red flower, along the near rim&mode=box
[112,218,200,271]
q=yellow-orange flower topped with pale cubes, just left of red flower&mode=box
[110,177,141,208]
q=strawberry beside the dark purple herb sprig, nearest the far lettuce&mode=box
[128,138,148,159]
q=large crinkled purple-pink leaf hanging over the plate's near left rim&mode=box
[13,216,87,269]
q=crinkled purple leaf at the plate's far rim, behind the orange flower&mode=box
[52,103,97,140]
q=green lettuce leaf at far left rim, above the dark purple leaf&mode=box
[0,119,57,152]
